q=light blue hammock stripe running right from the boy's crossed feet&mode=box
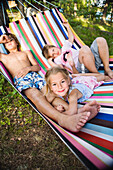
[84,123,113,136]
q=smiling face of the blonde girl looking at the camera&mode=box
[50,73,70,97]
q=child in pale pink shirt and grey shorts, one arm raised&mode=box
[42,22,113,78]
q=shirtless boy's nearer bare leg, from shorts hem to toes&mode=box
[24,88,97,132]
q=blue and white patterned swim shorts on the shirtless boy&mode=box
[14,72,46,92]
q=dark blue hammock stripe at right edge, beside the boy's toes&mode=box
[95,112,113,122]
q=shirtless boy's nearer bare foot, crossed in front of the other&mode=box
[58,112,90,132]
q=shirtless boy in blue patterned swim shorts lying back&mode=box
[0,33,100,132]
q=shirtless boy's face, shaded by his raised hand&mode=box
[4,38,18,51]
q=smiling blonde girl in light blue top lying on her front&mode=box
[45,66,109,115]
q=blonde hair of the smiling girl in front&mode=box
[45,66,69,94]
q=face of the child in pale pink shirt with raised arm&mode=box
[48,47,61,58]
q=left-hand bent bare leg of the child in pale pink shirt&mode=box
[79,45,99,73]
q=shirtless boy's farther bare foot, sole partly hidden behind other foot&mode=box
[78,100,101,120]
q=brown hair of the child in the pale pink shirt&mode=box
[42,44,55,59]
